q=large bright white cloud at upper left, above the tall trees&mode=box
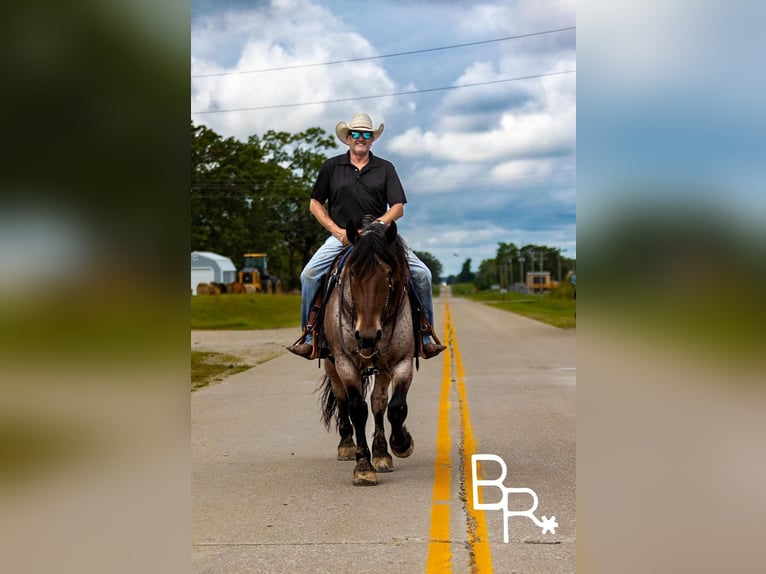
[191,0,395,139]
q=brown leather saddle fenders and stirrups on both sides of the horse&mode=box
[293,245,441,369]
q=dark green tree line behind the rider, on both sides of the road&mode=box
[191,121,572,290]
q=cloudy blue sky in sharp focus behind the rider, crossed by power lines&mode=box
[191,0,577,276]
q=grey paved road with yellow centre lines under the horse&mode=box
[191,297,576,574]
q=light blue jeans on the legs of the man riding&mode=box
[301,235,434,327]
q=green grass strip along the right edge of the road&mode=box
[452,284,577,329]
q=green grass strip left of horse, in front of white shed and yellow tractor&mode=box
[191,293,301,330]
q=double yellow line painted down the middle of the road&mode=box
[426,301,492,574]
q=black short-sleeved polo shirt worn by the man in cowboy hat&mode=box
[311,152,407,231]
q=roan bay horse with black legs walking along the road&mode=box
[321,223,415,486]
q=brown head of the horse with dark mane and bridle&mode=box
[346,219,404,355]
